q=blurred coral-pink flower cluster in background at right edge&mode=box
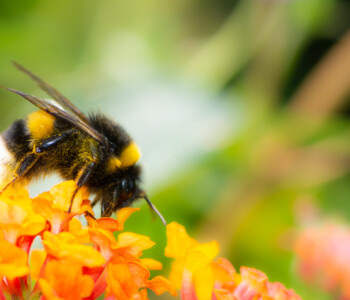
[295,223,350,299]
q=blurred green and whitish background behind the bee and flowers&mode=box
[0,0,350,299]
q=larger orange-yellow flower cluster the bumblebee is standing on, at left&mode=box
[0,181,176,300]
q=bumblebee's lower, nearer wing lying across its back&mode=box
[5,87,108,146]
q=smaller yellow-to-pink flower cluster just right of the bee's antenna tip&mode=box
[165,223,301,300]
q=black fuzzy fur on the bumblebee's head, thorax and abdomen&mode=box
[2,114,141,214]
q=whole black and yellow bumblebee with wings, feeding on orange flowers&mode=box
[0,63,165,224]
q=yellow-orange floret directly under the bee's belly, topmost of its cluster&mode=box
[33,180,93,233]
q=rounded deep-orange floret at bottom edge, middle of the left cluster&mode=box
[39,260,94,300]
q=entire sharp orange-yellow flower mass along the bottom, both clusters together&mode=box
[0,181,301,300]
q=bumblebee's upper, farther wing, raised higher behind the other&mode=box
[13,62,90,124]
